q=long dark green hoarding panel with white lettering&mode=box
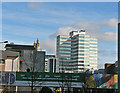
[16,72,85,83]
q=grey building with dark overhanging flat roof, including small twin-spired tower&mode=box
[5,40,45,72]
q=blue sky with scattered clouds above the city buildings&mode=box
[2,2,118,68]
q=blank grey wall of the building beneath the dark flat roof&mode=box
[20,50,45,72]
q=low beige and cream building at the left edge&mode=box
[0,51,20,72]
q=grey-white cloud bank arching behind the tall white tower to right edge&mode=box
[41,18,117,54]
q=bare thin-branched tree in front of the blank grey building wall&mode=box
[22,49,44,93]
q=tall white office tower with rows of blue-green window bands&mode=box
[56,30,97,73]
